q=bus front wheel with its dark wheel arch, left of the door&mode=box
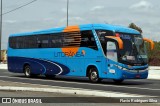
[87,66,102,83]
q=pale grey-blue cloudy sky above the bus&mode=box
[2,0,160,49]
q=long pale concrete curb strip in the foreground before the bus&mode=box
[0,86,151,97]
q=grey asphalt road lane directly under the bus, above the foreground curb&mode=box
[0,70,160,96]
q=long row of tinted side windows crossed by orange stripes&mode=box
[9,31,97,49]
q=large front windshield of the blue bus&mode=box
[117,33,148,65]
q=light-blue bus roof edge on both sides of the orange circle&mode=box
[10,24,140,36]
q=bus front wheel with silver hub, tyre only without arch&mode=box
[89,67,101,83]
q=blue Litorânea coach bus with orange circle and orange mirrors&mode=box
[7,24,154,83]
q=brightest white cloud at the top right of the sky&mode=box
[130,0,153,9]
